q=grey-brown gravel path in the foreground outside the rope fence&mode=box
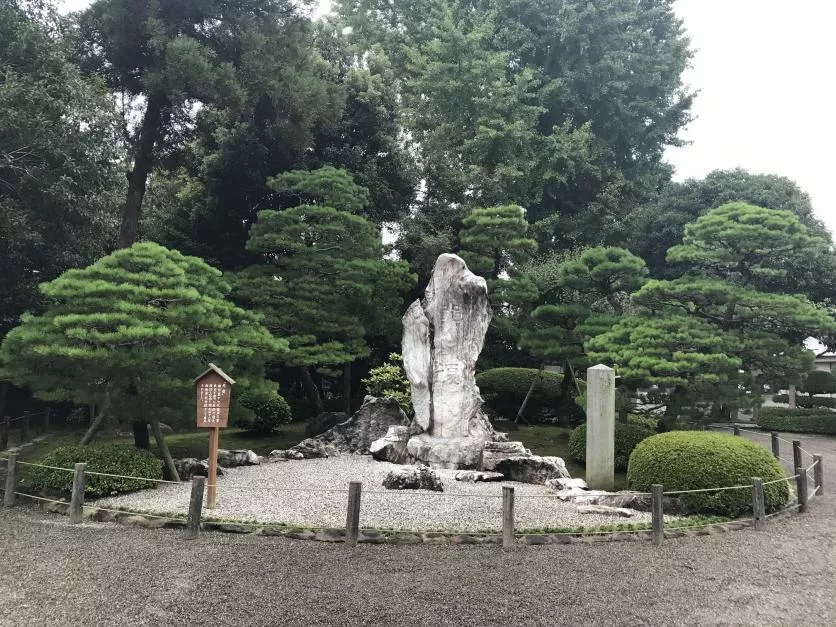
[0,436,836,627]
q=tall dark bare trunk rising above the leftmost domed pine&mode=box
[119,96,164,248]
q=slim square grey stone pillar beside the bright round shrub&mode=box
[586,364,615,490]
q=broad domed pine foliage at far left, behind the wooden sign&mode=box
[0,243,286,423]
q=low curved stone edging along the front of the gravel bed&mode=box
[31,502,772,545]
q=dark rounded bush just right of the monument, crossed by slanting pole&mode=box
[476,368,563,418]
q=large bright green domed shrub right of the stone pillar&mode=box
[627,431,789,518]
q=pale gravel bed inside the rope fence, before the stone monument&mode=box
[91,456,668,531]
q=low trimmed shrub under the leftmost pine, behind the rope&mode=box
[29,444,163,497]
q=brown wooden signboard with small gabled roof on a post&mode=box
[194,364,235,507]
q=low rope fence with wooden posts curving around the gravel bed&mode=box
[0,430,824,548]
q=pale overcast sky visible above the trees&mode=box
[60,0,836,232]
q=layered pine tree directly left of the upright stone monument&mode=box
[235,168,411,413]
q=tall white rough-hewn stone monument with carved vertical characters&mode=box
[403,254,493,468]
